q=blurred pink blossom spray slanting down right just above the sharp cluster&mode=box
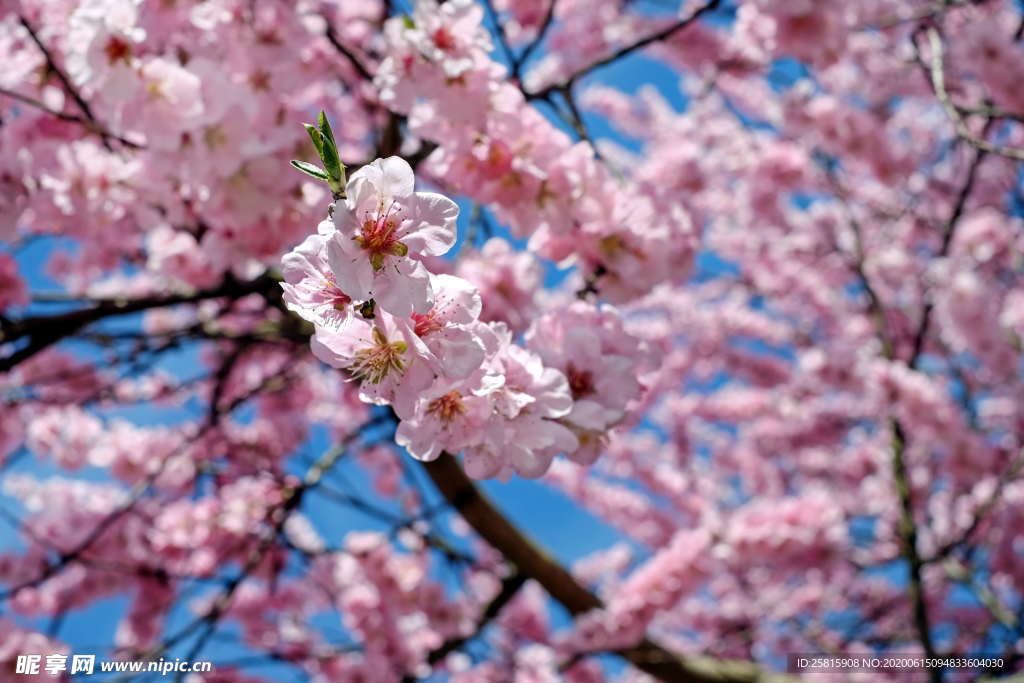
[375,0,697,302]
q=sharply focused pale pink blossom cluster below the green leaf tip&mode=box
[282,157,646,478]
